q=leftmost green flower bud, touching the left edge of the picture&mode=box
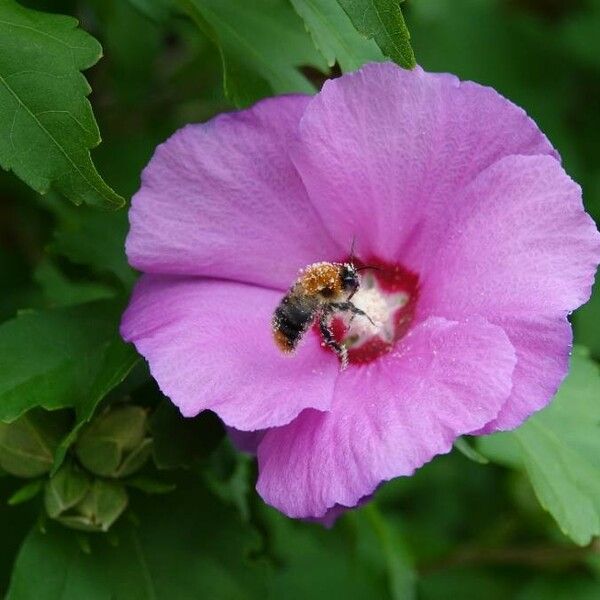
[0,408,69,477]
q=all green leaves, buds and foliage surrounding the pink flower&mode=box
[0,0,600,600]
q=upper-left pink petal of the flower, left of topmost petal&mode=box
[126,96,347,289]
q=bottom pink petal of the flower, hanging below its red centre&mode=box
[257,317,516,517]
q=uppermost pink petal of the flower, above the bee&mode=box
[292,63,554,272]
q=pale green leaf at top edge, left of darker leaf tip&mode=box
[291,0,385,72]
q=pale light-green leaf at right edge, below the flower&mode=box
[479,348,600,545]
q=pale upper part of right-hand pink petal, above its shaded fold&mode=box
[419,156,600,319]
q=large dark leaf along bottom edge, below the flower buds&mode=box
[7,473,266,600]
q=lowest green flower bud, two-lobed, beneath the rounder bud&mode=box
[44,464,129,532]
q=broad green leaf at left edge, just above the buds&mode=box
[0,302,133,421]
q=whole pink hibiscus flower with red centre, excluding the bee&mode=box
[121,64,600,517]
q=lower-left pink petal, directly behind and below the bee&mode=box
[121,275,339,430]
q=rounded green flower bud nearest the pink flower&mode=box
[75,405,152,478]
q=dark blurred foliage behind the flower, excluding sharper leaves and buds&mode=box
[0,0,600,600]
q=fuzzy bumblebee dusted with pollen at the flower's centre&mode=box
[272,262,372,369]
